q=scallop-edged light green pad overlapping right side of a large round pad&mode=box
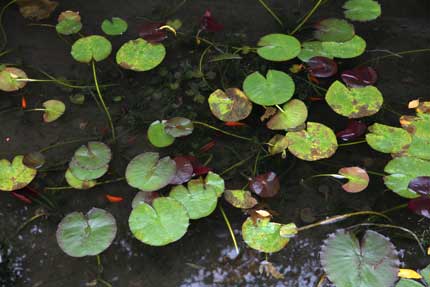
[169,178,218,219]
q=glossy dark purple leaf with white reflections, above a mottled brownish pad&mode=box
[249,171,281,197]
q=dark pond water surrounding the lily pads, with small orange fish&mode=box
[0,0,430,287]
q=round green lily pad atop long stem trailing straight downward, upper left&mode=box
[71,35,112,63]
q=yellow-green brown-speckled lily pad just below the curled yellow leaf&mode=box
[116,38,166,72]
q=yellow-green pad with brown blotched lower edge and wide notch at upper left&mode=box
[325,81,384,119]
